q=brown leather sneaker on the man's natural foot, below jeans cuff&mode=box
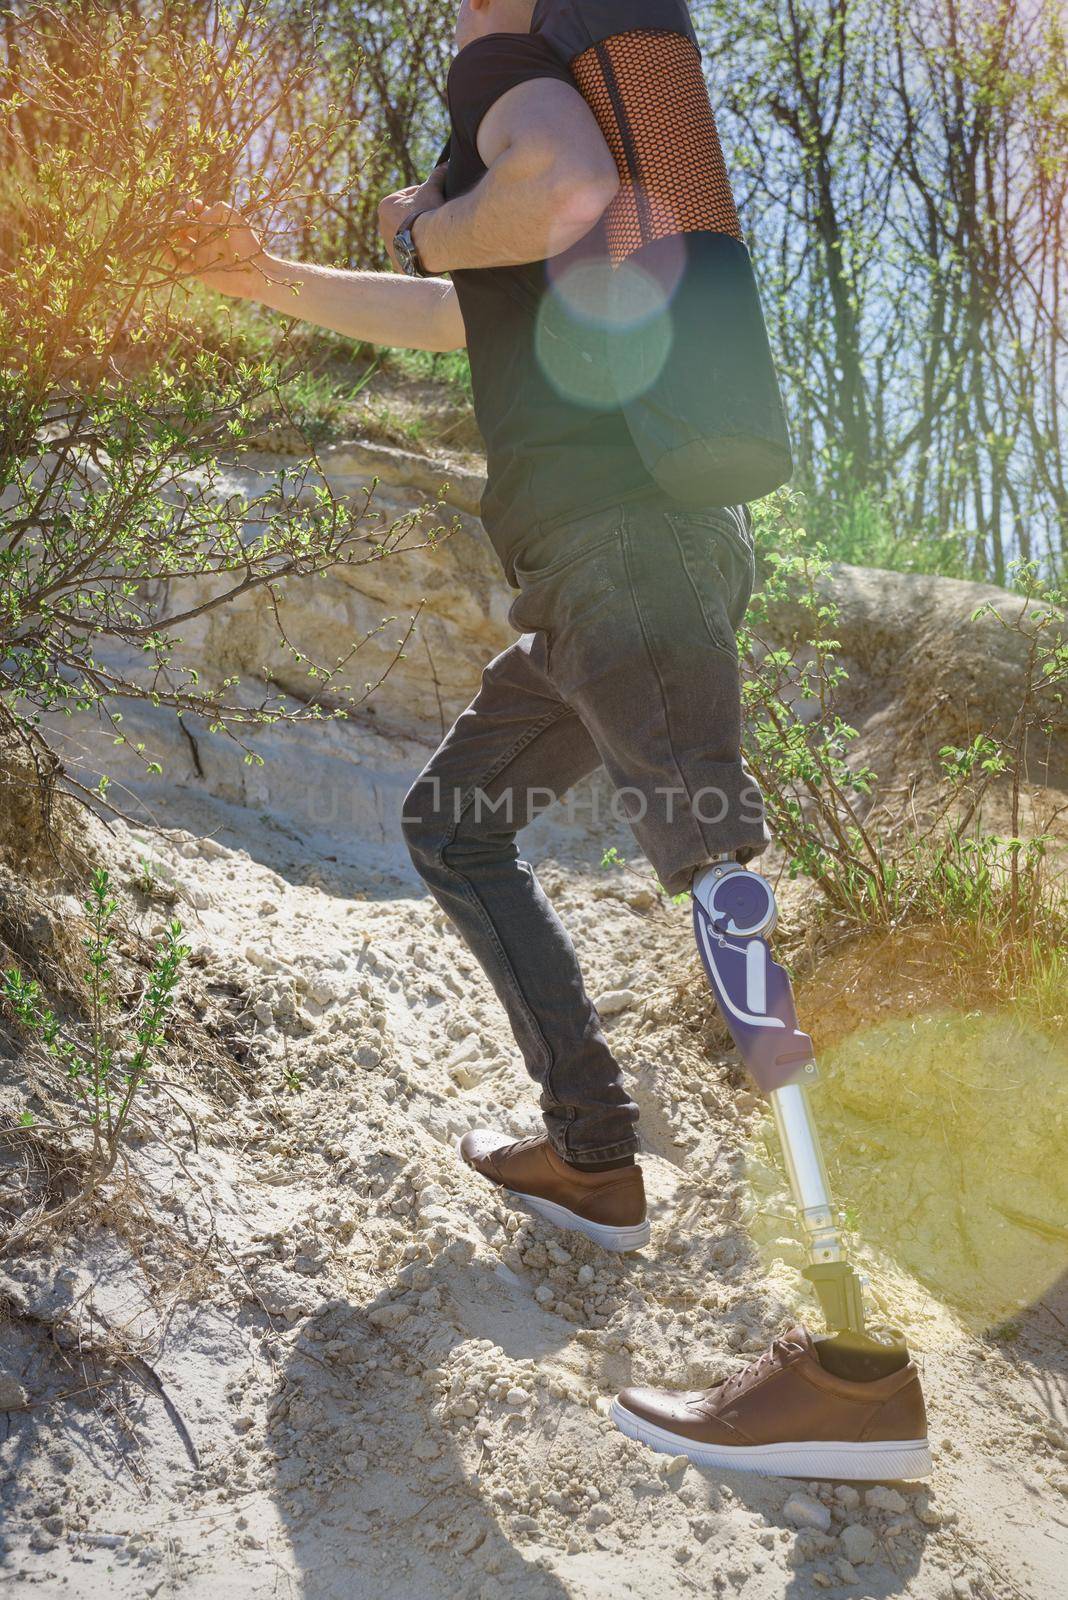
[459,1128,649,1250]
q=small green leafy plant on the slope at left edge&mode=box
[0,867,189,1240]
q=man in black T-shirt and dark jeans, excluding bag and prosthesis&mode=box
[167,0,913,1474]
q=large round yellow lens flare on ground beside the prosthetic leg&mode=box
[750,1010,1068,1331]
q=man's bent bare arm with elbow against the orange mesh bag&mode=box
[412,78,619,272]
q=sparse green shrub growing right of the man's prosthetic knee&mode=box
[740,491,1068,1014]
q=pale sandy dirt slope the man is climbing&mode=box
[0,438,1068,1600]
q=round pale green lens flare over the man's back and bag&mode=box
[534,262,673,411]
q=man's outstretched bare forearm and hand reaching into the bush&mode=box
[163,200,467,350]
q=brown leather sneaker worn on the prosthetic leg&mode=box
[612,1328,931,1478]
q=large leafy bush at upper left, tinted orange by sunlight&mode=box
[0,0,435,812]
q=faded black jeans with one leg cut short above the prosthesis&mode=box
[403,502,769,1165]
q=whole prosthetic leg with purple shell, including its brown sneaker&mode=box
[611,859,931,1482]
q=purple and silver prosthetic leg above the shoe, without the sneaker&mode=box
[692,859,863,1333]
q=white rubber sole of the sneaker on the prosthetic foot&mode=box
[611,1400,932,1482]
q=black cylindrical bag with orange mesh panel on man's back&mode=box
[532,0,793,507]
